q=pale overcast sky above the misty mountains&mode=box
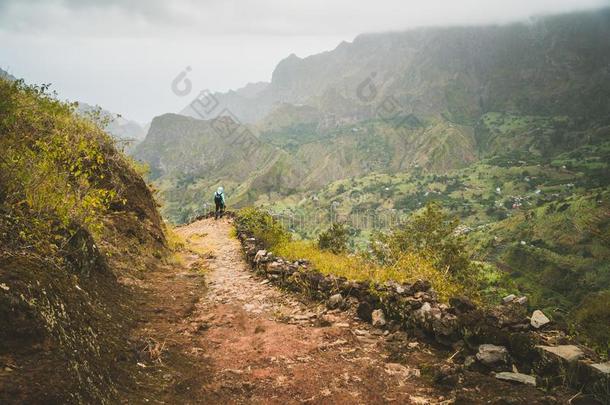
[0,0,610,123]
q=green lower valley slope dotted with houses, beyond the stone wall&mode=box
[269,138,610,347]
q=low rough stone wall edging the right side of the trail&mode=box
[238,226,610,403]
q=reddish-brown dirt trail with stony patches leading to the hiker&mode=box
[127,219,564,404]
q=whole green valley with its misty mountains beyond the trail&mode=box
[128,9,610,352]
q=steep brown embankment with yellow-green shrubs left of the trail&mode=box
[0,79,167,403]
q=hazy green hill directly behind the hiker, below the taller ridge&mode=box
[133,114,312,222]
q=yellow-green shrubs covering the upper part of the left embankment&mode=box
[0,80,124,254]
